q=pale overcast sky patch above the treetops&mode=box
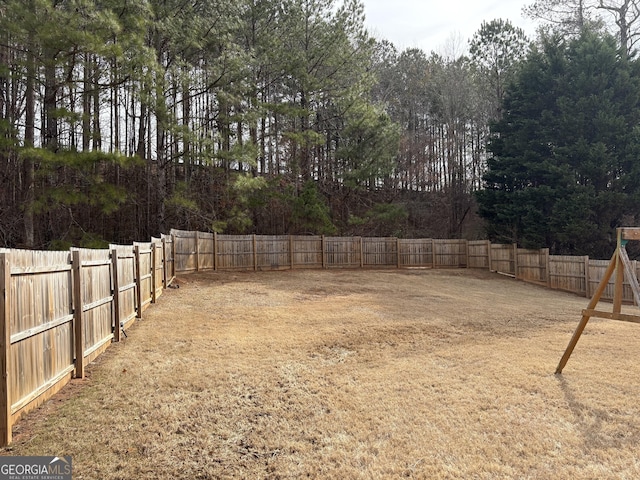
[363,0,535,54]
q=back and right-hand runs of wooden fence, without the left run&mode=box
[171,230,638,303]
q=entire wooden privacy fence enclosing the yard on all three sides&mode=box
[0,230,638,446]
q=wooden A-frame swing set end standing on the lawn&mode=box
[555,227,640,374]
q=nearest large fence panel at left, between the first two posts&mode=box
[0,250,75,444]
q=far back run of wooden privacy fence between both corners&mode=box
[171,230,476,273]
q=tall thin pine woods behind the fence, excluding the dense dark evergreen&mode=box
[0,0,637,258]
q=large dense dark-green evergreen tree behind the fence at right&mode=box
[477,31,640,257]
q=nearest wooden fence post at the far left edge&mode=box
[0,253,12,447]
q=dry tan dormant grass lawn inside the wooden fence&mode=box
[4,270,640,479]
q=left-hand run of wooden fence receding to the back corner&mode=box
[0,235,175,445]
